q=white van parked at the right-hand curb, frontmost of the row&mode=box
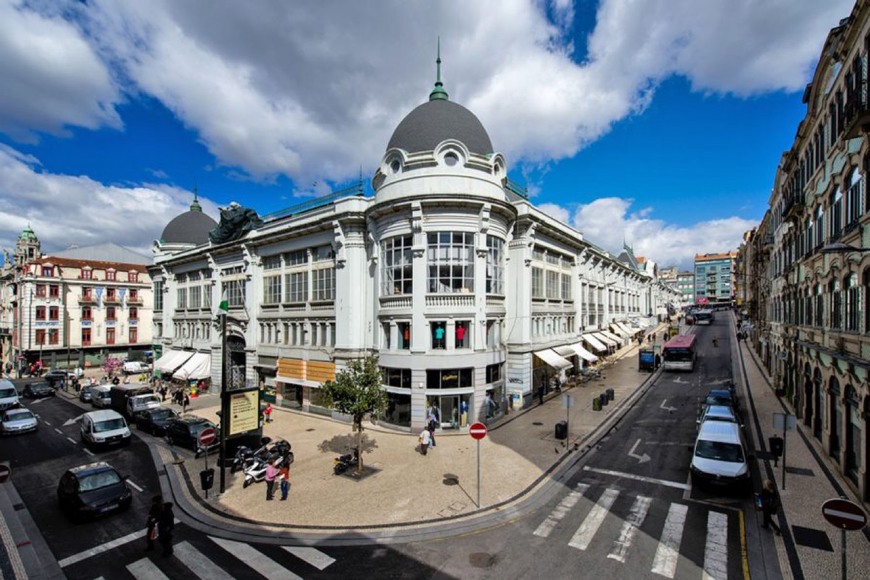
[690,421,752,491]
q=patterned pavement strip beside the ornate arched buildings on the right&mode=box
[735,322,870,578]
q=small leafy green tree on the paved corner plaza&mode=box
[320,356,388,473]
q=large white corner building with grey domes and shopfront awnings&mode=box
[150,58,676,430]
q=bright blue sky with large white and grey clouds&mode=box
[0,0,853,267]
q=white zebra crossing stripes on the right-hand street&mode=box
[533,483,729,580]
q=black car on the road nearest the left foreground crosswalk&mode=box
[57,461,133,519]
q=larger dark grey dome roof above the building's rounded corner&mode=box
[387,99,494,155]
